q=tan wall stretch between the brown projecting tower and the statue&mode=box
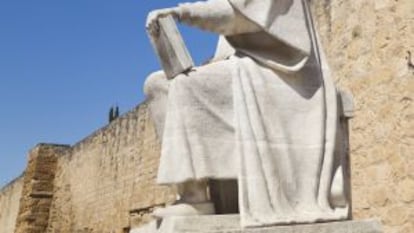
[47,103,175,233]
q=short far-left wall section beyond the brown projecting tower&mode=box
[0,176,23,233]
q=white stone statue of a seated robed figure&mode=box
[144,0,349,227]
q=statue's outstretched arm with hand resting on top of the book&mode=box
[147,0,260,36]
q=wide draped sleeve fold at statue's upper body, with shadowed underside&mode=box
[228,0,312,72]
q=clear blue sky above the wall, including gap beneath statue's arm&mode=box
[0,0,217,187]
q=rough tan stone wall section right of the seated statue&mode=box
[312,0,414,233]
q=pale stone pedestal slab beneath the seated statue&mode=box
[130,215,383,233]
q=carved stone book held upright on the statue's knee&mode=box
[148,16,194,79]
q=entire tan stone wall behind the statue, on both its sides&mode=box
[0,0,414,233]
